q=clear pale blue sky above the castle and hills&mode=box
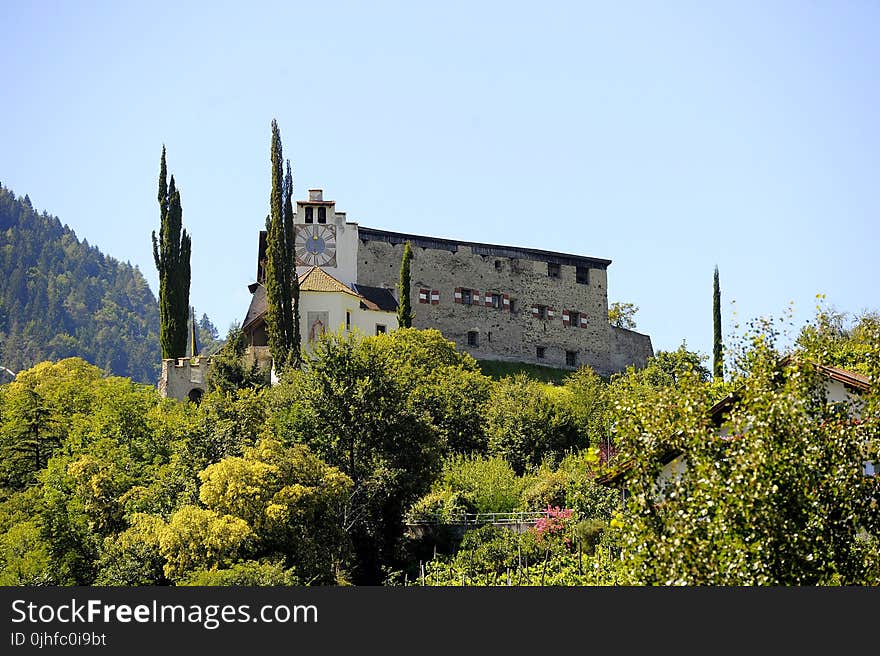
[0,0,880,364]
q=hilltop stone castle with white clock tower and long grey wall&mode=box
[242,189,653,375]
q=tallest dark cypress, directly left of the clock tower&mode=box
[266,119,299,373]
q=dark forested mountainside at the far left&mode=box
[0,185,160,384]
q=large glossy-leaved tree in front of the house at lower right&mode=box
[619,332,880,585]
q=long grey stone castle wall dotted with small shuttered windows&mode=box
[357,233,653,375]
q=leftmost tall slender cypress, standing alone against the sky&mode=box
[153,146,192,358]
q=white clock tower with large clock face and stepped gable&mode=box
[294,189,358,284]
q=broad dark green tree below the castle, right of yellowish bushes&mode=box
[270,329,445,584]
